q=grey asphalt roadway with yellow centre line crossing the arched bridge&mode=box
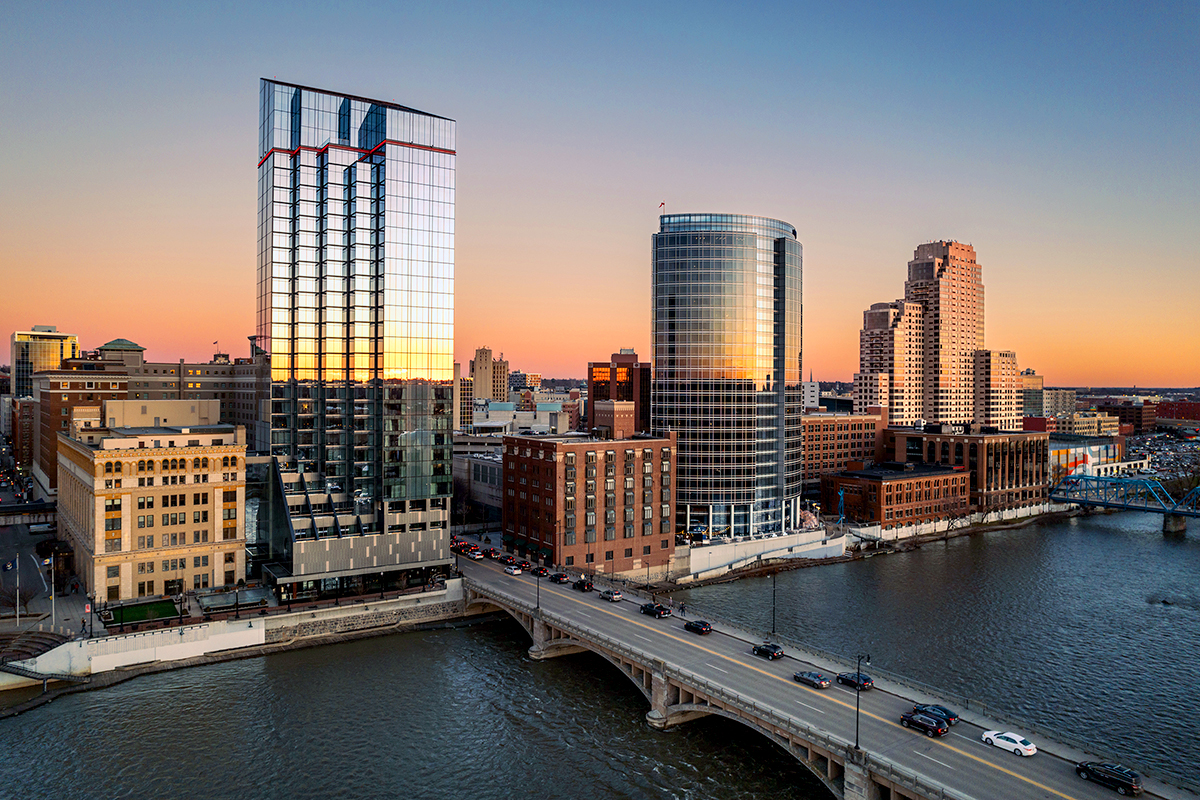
[461,559,1176,800]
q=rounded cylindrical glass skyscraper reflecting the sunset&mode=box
[652,213,804,536]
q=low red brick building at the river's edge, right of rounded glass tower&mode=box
[821,462,970,528]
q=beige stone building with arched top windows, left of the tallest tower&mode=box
[59,399,246,602]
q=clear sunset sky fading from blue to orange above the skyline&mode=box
[0,0,1200,386]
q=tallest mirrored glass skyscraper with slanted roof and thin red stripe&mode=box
[256,79,455,590]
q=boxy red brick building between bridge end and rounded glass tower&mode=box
[503,433,676,575]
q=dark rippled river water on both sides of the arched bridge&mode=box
[0,513,1200,800]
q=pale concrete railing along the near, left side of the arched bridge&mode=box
[467,579,966,800]
